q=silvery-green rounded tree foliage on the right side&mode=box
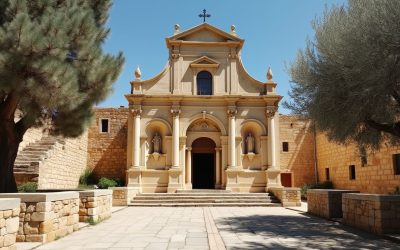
[284,0,400,149]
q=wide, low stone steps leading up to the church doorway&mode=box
[129,189,282,207]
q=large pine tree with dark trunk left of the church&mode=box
[0,0,124,192]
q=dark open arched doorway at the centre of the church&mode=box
[192,137,216,189]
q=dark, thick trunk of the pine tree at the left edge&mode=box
[0,120,24,193]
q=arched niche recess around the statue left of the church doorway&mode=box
[145,118,172,154]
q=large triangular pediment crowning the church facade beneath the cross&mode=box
[168,23,243,42]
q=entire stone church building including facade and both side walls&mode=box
[14,23,400,193]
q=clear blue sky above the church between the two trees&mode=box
[99,0,346,113]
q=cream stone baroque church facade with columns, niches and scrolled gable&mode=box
[126,23,282,192]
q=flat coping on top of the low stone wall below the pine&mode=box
[0,191,79,202]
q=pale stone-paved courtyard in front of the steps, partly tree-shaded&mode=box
[34,207,400,250]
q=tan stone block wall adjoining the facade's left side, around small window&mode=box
[87,108,129,180]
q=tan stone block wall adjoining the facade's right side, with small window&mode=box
[279,115,315,187]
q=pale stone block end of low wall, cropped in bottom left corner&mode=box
[0,198,20,249]
